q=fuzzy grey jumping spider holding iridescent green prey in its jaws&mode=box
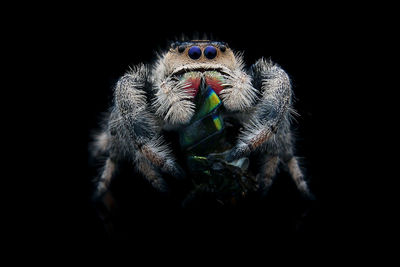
[93,40,310,207]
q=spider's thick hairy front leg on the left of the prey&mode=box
[115,65,182,181]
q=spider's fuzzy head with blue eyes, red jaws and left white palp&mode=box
[153,40,243,124]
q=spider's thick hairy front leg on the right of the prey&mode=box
[228,59,292,160]
